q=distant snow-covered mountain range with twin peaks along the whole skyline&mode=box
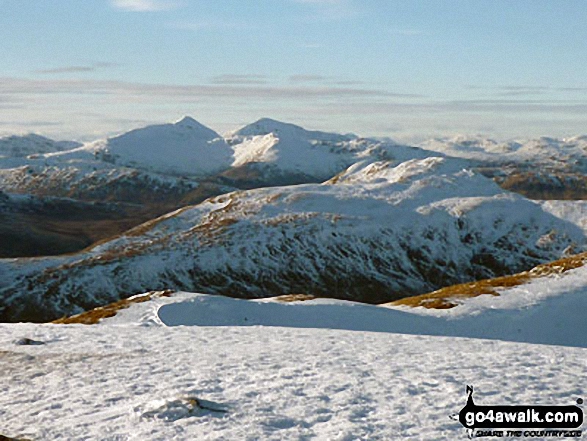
[0,117,587,201]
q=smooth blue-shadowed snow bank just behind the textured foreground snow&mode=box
[100,288,587,348]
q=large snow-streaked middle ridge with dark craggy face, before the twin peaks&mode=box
[0,158,585,321]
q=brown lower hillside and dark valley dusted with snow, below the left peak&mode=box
[0,153,233,257]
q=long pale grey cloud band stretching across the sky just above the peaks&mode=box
[11,75,587,114]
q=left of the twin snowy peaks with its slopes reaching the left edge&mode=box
[0,117,243,206]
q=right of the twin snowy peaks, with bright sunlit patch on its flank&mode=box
[223,118,438,188]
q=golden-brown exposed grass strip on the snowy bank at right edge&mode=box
[385,253,587,309]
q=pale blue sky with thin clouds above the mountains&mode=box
[0,0,587,141]
